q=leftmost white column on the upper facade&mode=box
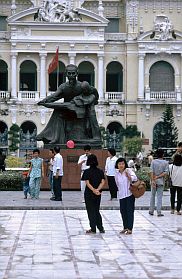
[11,52,17,99]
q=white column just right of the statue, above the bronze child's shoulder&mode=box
[97,54,104,100]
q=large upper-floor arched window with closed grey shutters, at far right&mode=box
[149,61,175,92]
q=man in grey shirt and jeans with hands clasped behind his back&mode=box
[149,149,169,217]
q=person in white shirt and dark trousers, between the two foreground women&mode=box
[105,148,118,201]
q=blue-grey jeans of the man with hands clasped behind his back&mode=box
[149,185,164,214]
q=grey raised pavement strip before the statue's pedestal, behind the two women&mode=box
[0,191,170,210]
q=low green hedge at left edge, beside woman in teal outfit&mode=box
[0,171,23,191]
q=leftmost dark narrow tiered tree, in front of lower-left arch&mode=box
[8,124,20,152]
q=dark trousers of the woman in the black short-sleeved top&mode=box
[85,195,104,232]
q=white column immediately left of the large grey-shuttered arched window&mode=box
[138,53,145,99]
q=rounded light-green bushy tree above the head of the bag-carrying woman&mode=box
[123,137,143,157]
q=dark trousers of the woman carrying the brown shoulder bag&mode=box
[119,195,135,230]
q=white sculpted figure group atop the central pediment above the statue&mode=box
[34,1,82,23]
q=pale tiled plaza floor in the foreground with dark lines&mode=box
[0,210,182,279]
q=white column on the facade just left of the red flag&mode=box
[39,53,47,99]
